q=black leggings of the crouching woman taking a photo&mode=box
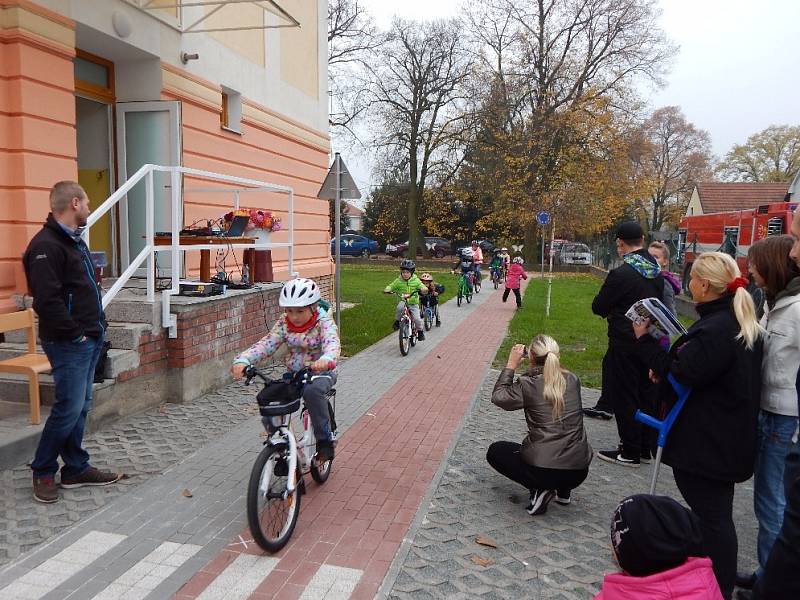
[486,442,589,498]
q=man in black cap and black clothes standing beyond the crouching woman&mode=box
[592,221,664,467]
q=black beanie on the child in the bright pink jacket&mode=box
[611,494,706,577]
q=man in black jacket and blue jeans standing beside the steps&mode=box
[22,181,119,503]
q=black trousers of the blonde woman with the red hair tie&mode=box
[672,469,739,600]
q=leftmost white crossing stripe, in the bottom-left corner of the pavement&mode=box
[0,531,127,600]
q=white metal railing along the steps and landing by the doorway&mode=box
[83,164,297,337]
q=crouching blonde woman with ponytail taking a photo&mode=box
[486,334,592,515]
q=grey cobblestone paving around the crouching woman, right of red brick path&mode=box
[381,370,756,600]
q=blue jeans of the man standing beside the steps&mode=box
[31,337,103,478]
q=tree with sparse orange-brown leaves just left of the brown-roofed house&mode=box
[630,106,712,231]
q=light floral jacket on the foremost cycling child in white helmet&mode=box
[234,308,341,373]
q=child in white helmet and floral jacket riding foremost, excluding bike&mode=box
[231,278,341,461]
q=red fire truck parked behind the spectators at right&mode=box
[678,202,798,291]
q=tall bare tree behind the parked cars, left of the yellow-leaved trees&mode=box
[368,19,471,257]
